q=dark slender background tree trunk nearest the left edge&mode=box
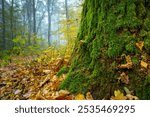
[2,0,6,50]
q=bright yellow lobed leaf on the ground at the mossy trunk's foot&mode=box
[111,90,127,100]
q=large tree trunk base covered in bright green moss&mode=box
[61,0,150,99]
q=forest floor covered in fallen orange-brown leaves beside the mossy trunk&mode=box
[0,50,93,100]
